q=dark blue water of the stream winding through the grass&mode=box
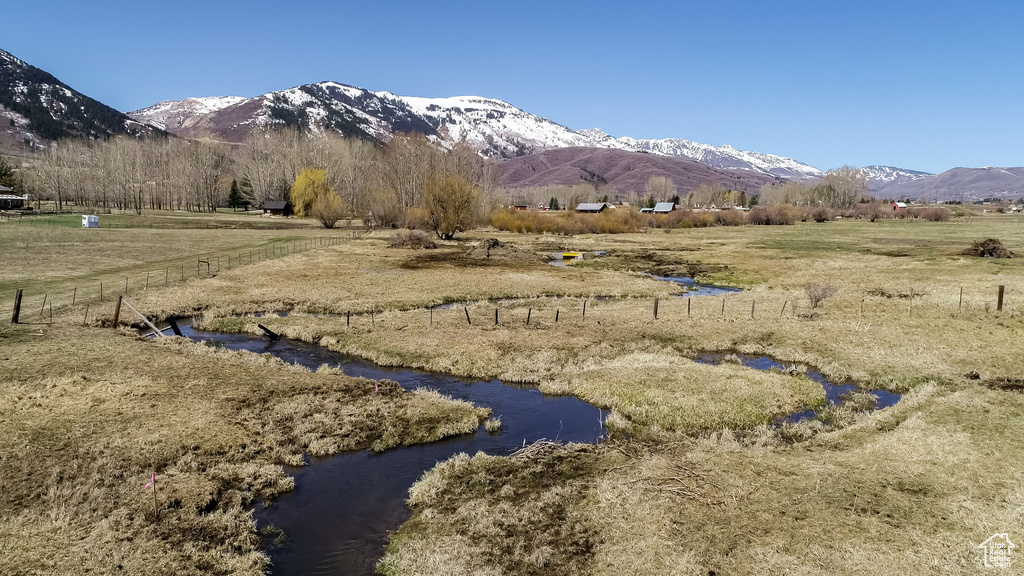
[155,315,899,576]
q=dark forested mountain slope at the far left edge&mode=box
[0,50,154,146]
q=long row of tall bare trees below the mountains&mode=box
[12,129,494,227]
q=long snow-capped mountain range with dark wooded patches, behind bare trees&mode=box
[130,82,822,178]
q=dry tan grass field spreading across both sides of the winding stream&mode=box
[0,212,1024,575]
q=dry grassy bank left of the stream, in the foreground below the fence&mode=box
[0,325,487,574]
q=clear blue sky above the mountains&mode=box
[0,0,1024,172]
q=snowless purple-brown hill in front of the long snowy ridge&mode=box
[499,148,778,195]
